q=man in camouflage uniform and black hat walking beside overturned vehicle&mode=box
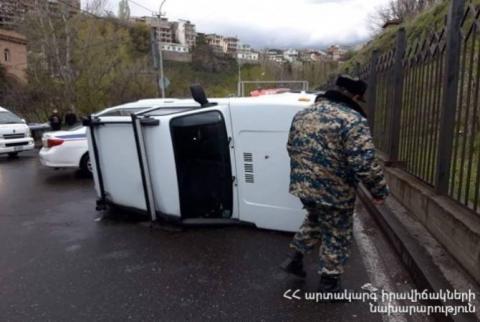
[281,76,388,292]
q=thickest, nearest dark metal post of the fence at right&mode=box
[435,0,465,195]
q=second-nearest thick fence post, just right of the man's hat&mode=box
[387,27,407,163]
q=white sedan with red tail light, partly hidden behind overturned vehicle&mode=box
[39,100,162,174]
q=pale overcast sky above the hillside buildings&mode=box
[82,0,389,48]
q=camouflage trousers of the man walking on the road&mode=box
[290,205,353,274]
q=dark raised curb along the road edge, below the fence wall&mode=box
[358,185,476,321]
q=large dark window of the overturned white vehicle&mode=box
[170,111,233,218]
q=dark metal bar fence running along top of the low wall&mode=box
[358,0,480,212]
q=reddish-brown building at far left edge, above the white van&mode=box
[0,29,27,83]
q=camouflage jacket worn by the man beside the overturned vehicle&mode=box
[287,93,388,209]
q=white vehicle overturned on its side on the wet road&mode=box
[85,87,316,231]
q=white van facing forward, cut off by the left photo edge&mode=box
[0,107,34,156]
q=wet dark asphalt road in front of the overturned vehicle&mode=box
[0,153,381,321]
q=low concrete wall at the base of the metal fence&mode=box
[385,168,480,283]
